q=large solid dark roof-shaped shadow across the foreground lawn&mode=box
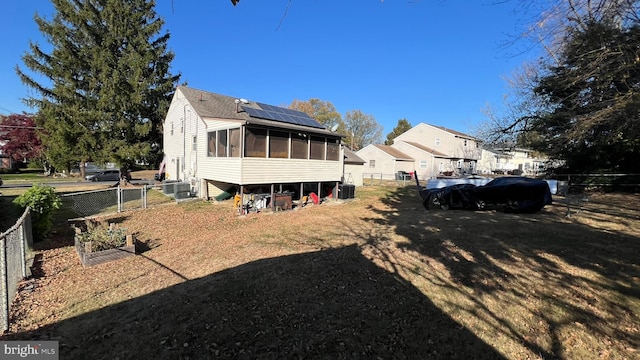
[7,245,503,359]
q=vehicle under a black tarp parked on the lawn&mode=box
[420,176,552,213]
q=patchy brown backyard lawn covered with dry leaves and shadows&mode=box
[4,187,640,359]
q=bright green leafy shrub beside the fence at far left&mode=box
[13,184,62,241]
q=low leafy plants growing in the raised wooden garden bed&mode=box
[74,220,127,252]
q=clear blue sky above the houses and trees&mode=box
[0,0,532,135]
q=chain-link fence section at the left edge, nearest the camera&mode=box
[0,208,33,332]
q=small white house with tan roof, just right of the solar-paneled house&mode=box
[356,144,414,180]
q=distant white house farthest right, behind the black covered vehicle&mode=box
[478,146,548,175]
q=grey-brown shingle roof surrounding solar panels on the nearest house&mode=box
[172,86,343,137]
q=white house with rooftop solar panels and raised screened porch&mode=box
[163,86,344,200]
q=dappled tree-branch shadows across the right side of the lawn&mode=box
[362,187,640,359]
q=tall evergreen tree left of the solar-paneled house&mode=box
[16,0,179,175]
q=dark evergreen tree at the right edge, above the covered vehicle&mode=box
[530,22,640,172]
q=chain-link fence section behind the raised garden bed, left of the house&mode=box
[60,186,151,217]
